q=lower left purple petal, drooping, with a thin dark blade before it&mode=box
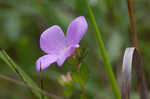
[36,55,58,73]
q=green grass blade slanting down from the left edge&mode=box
[0,50,48,99]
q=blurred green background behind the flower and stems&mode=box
[0,0,150,99]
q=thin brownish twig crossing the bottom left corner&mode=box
[0,74,62,99]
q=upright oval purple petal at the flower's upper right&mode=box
[66,16,88,45]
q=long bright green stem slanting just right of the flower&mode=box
[86,0,121,99]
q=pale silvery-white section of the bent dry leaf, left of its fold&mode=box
[121,48,135,99]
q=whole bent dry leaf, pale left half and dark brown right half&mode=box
[120,47,148,99]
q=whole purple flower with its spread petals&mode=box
[36,16,88,73]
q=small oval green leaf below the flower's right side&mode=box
[80,63,89,85]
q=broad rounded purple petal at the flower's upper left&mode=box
[40,25,66,54]
